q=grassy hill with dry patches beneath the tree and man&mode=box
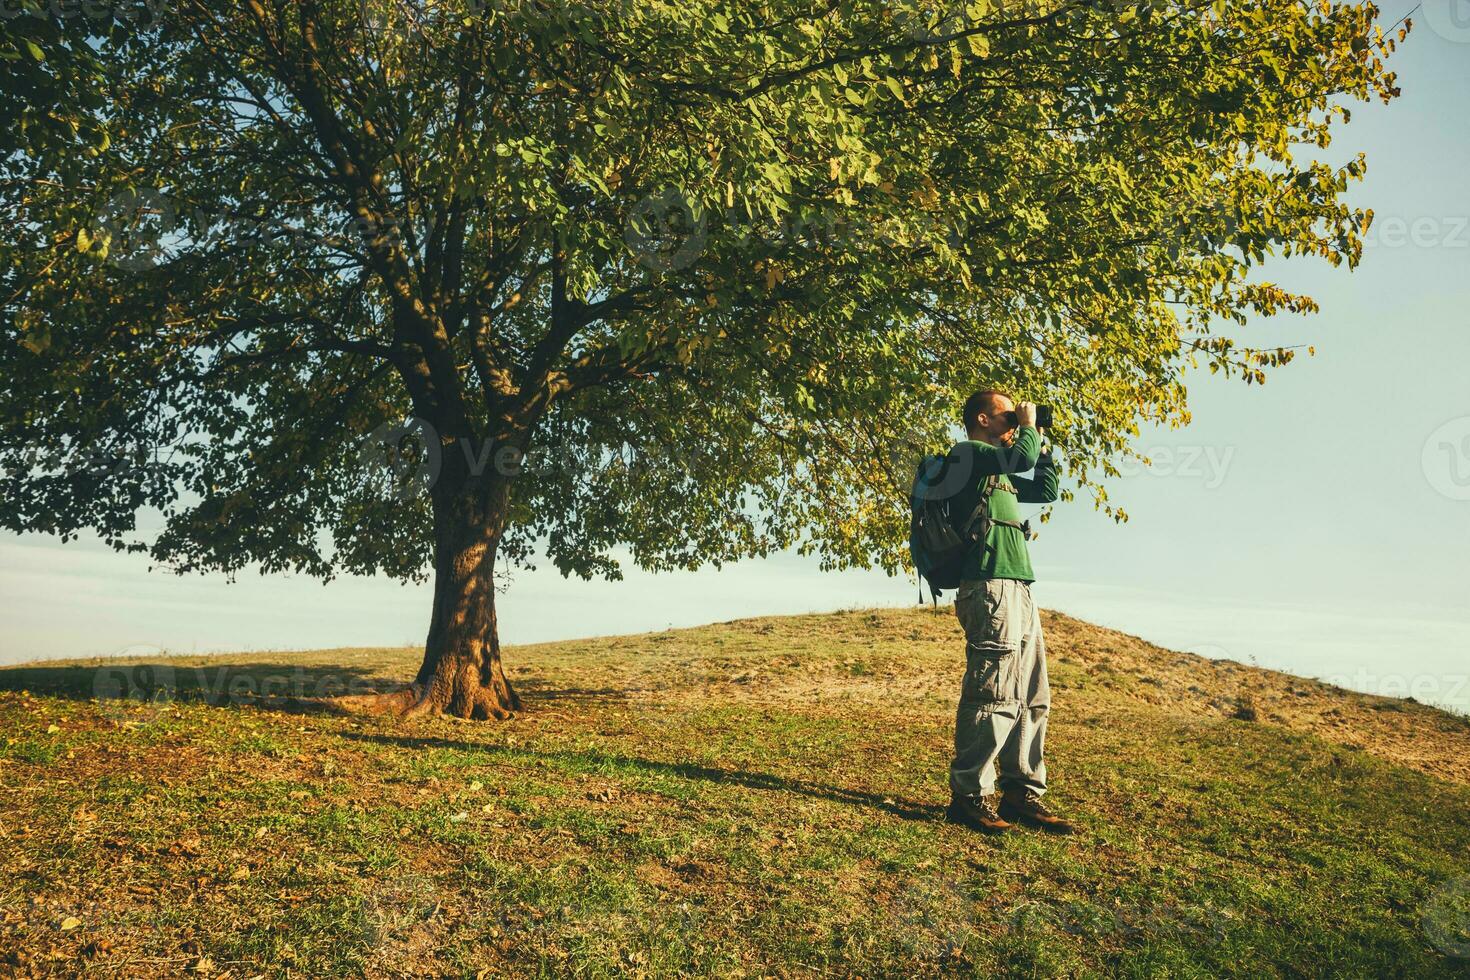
[0,608,1470,977]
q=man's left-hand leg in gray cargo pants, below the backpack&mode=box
[950,579,1022,798]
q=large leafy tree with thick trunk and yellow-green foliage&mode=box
[0,0,1401,718]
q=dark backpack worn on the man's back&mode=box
[908,454,1030,607]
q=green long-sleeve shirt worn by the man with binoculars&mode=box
[950,426,1057,582]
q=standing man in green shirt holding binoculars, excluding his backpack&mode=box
[945,389,1072,833]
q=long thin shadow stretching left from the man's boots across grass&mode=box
[338,732,944,821]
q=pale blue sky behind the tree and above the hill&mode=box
[0,17,1470,710]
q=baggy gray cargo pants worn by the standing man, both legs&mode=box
[950,579,1051,796]
